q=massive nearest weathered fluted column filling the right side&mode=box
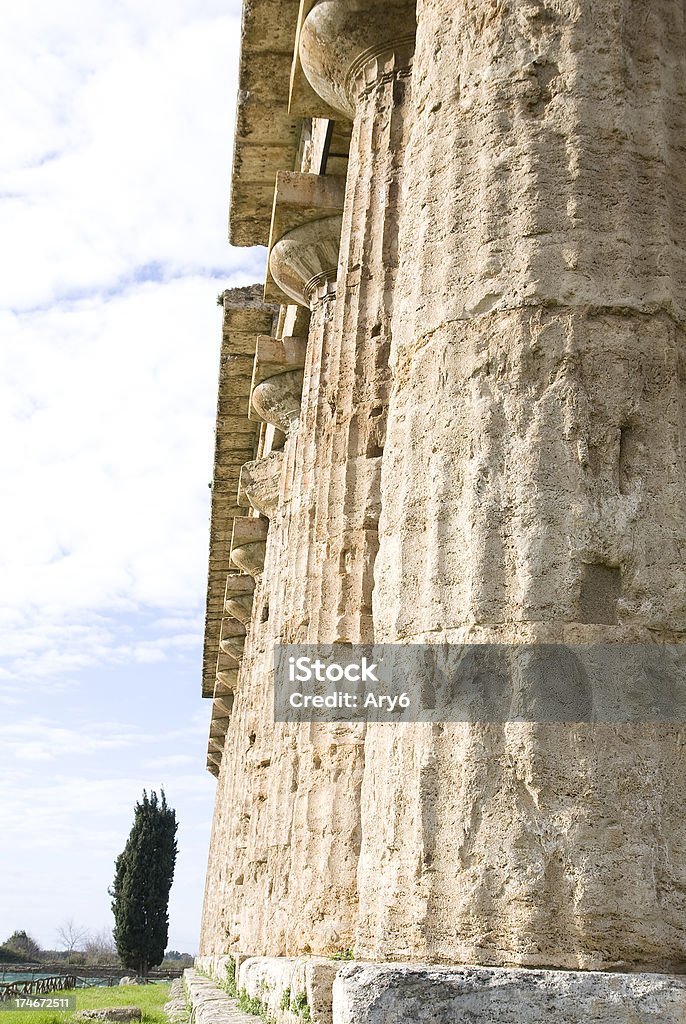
[359,0,686,970]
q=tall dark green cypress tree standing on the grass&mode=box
[109,790,178,978]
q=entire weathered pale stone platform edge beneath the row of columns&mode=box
[192,956,686,1024]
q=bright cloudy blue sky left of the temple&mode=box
[0,0,264,952]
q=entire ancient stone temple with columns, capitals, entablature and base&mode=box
[192,0,686,1024]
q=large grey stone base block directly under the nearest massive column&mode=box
[333,964,686,1024]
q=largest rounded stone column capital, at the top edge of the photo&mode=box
[297,0,417,118]
